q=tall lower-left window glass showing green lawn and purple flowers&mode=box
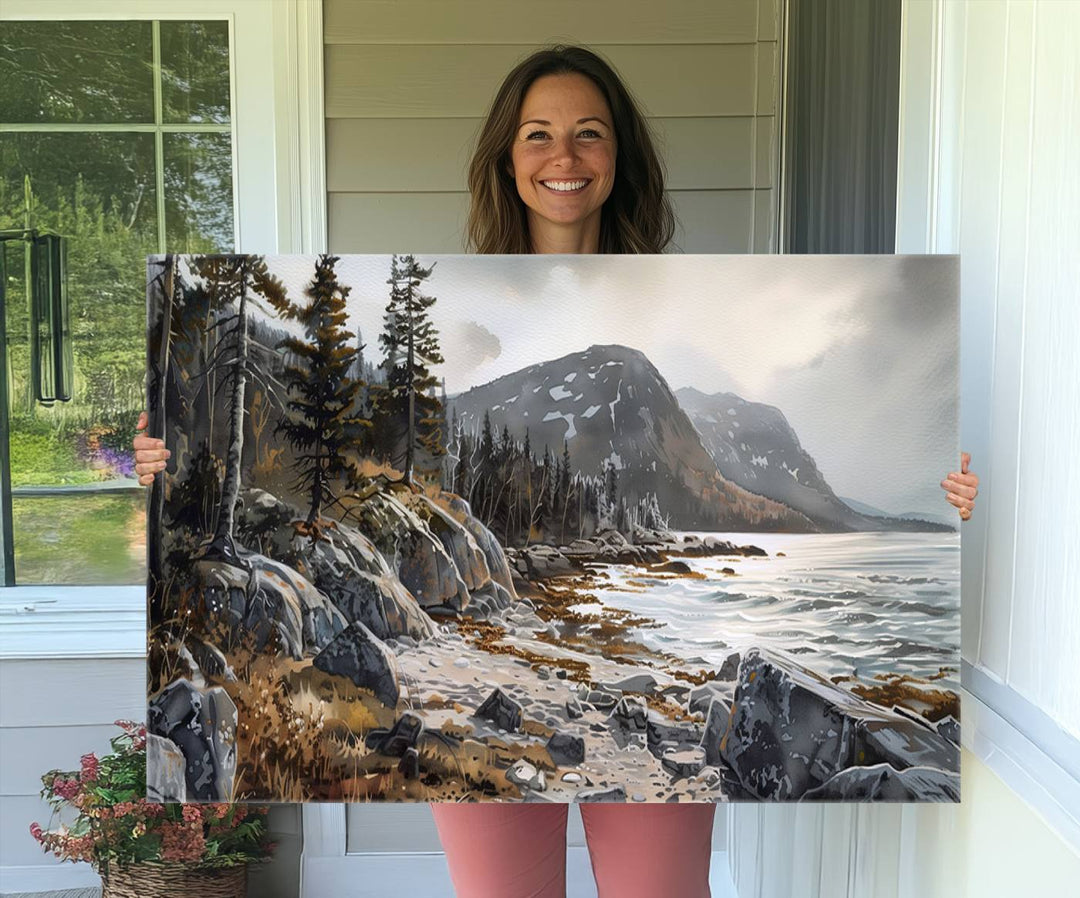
[0,133,158,584]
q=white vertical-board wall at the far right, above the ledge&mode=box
[995,2,1080,739]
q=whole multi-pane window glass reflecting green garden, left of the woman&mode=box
[0,21,234,585]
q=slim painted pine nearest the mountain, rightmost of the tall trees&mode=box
[376,255,446,483]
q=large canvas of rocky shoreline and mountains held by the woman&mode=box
[148,254,960,802]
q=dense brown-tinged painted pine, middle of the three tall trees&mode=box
[268,255,370,528]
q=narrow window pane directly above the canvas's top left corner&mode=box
[164,134,233,253]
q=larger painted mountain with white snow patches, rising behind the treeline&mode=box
[449,346,816,531]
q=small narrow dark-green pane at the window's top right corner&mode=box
[161,21,229,123]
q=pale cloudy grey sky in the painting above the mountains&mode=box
[268,255,959,513]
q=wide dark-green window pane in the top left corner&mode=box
[0,22,153,123]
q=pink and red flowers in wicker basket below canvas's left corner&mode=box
[30,721,275,898]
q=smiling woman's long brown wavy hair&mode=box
[468,45,675,253]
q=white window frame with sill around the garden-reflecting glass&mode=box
[0,0,326,658]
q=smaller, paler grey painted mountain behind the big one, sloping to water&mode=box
[676,387,953,531]
